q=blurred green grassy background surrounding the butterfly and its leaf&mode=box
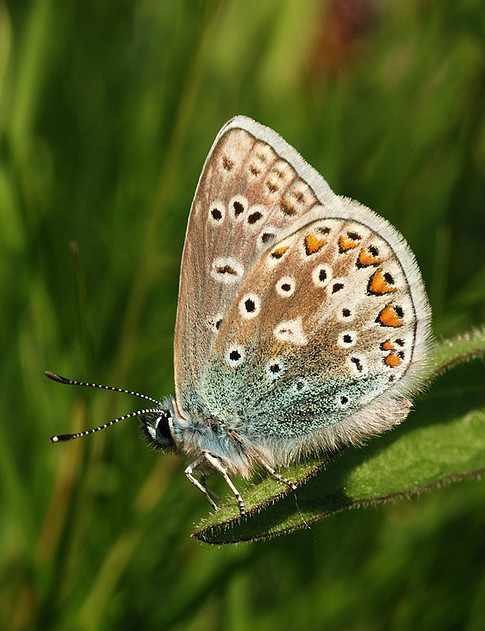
[0,0,485,631]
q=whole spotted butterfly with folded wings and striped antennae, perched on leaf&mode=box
[46,116,431,514]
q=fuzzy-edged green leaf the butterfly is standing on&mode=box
[193,331,485,544]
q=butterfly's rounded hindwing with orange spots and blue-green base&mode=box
[201,199,430,463]
